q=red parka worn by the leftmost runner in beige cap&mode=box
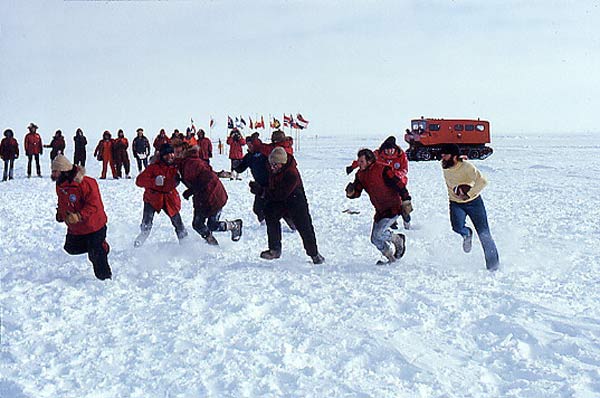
[56,166,108,235]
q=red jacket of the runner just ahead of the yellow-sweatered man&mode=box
[351,161,410,222]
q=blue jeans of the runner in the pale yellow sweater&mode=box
[450,196,500,269]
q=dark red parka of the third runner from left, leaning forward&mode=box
[179,148,227,216]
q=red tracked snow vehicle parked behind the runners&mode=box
[404,117,493,160]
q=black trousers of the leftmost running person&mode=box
[65,225,112,280]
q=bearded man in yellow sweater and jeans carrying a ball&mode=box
[440,144,500,271]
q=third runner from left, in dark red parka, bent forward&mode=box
[179,146,242,245]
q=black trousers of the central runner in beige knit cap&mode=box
[265,188,319,257]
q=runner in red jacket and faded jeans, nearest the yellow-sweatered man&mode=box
[346,149,412,265]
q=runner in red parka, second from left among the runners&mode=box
[133,144,187,247]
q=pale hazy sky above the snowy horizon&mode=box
[0,0,600,141]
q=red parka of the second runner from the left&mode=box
[135,160,181,217]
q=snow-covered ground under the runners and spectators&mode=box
[0,135,600,398]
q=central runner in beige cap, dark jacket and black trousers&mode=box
[249,148,325,264]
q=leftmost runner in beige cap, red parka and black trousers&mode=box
[51,155,112,280]
